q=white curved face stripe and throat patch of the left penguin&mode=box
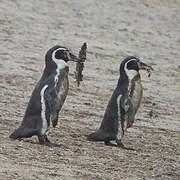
[52,48,68,87]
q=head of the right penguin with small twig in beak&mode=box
[120,56,153,78]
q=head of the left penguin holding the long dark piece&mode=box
[46,45,79,64]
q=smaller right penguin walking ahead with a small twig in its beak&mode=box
[87,56,153,149]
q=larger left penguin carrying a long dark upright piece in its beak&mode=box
[9,45,79,145]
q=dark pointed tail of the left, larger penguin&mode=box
[9,126,37,139]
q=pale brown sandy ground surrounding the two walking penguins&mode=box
[0,0,180,180]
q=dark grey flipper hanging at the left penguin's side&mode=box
[44,87,59,127]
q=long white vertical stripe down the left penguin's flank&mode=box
[40,85,48,134]
